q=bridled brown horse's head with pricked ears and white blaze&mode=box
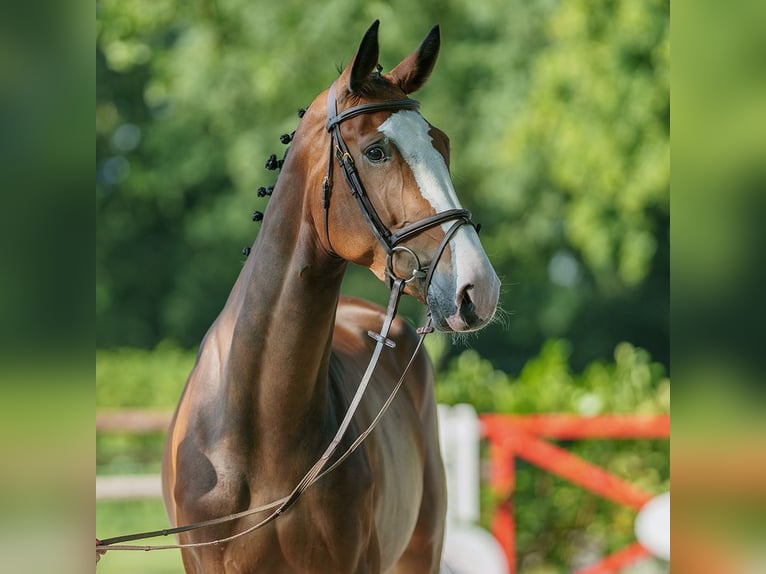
[304,21,500,332]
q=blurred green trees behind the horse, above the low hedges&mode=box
[96,0,669,372]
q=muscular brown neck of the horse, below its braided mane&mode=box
[216,119,346,452]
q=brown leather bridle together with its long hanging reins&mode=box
[96,84,476,555]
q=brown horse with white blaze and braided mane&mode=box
[162,21,500,574]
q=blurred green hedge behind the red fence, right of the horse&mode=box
[436,340,670,572]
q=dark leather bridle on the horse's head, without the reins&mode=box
[322,84,476,296]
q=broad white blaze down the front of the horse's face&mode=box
[378,110,486,296]
